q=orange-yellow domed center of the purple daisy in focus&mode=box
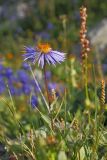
[37,43,51,54]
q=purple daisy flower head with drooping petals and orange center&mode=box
[23,43,65,68]
